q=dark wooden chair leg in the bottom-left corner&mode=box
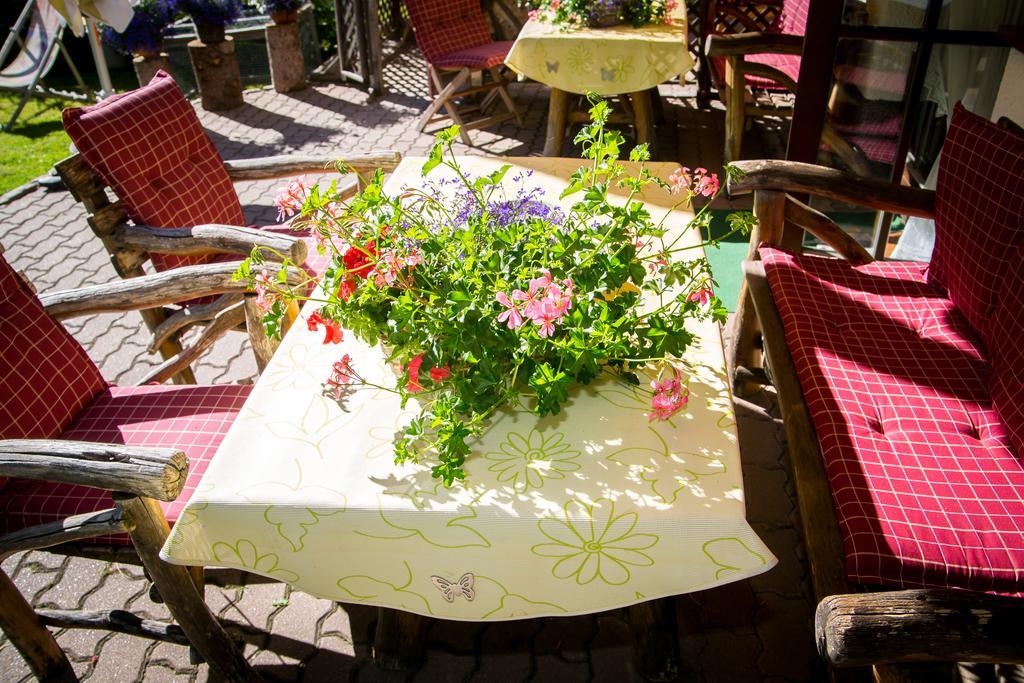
[0,571,78,682]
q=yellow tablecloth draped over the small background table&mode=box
[505,18,693,95]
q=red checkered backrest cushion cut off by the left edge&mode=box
[0,257,106,438]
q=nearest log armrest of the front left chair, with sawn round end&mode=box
[0,439,188,501]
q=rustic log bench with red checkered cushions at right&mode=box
[729,106,1024,680]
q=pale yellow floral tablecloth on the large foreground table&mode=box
[162,157,776,621]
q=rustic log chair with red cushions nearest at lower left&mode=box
[0,249,301,681]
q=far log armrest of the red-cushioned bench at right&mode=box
[728,160,935,218]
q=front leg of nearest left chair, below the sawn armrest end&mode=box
[114,494,261,681]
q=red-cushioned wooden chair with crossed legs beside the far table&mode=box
[406,0,522,145]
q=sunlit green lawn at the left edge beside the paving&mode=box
[0,92,71,195]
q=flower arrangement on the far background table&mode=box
[529,0,679,29]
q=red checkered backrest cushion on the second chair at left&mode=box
[63,71,245,270]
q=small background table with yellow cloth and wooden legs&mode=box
[505,15,693,157]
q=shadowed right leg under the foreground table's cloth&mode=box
[626,598,679,681]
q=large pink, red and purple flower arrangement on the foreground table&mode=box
[236,100,753,485]
